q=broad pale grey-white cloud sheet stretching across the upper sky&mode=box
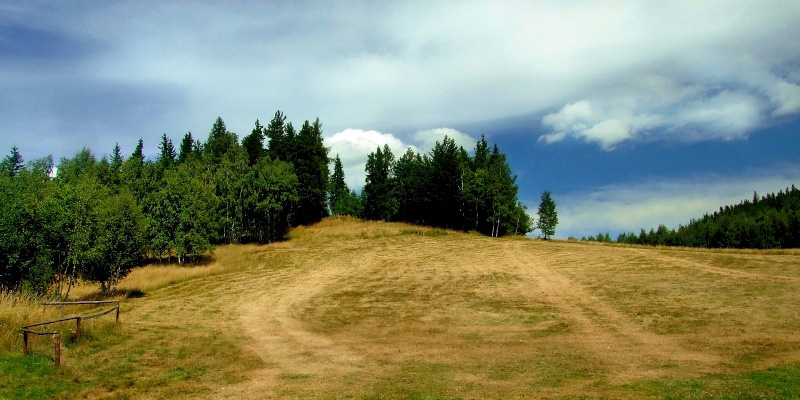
[0,0,800,158]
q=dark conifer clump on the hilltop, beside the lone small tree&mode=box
[331,137,533,237]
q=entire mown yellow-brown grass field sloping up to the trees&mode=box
[0,218,800,399]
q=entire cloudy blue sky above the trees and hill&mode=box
[0,0,800,238]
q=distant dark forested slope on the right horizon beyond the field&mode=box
[582,185,800,249]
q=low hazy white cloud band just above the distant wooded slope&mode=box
[552,165,800,238]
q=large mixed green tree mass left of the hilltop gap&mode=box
[0,111,328,296]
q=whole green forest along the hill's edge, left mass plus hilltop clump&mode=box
[0,111,533,298]
